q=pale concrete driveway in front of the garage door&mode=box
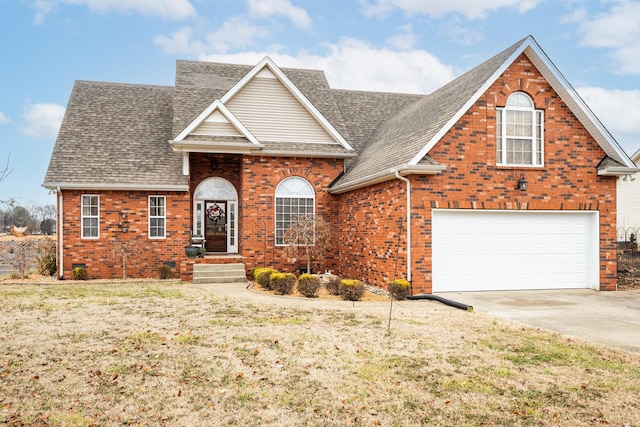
[438,289,640,353]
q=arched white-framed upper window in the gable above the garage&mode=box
[496,92,544,166]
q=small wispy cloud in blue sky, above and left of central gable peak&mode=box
[154,16,269,56]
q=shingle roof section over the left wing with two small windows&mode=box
[44,81,188,188]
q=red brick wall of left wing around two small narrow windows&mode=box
[58,190,191,279]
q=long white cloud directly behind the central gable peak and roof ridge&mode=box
[200,38,454,93]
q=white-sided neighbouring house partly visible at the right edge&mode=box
[616,150,640,245]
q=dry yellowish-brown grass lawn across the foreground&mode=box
[0,281,640,426]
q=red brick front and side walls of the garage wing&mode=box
[341,55,617,293]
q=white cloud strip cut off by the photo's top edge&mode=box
[361,0,546,19]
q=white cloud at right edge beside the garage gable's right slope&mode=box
[576,86,640,155]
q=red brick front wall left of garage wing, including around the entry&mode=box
[63,154,343,280]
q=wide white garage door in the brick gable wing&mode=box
[432,209,599,292]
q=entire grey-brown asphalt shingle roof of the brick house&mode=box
[44,38,636,191]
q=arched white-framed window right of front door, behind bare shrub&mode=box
[275,176,315,246]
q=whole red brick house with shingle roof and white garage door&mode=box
[43,36,638,293]
